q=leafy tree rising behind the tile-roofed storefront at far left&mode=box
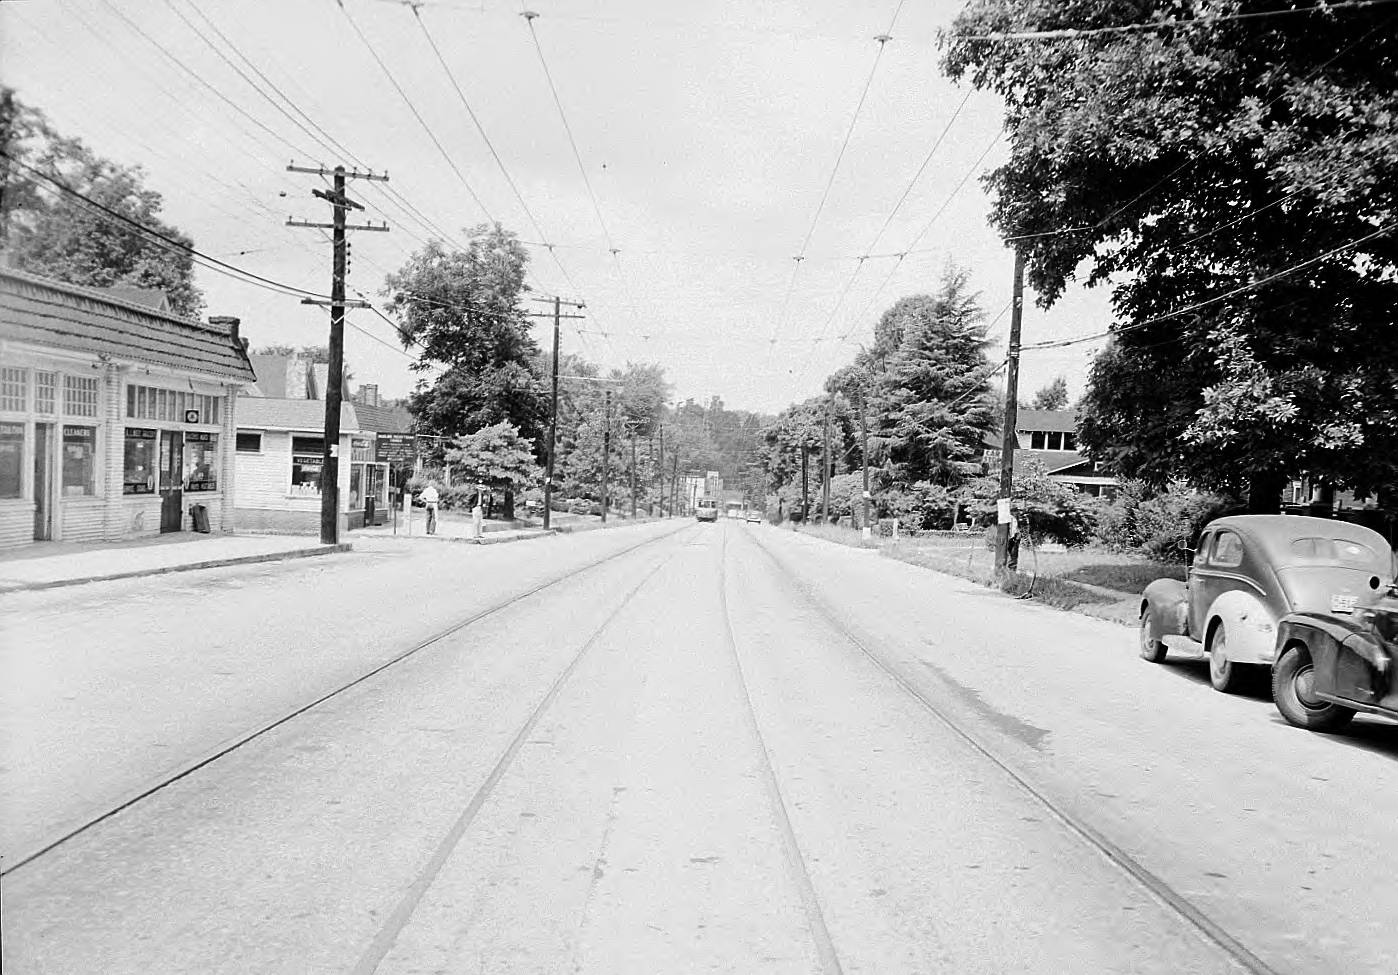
[0,87,204,318]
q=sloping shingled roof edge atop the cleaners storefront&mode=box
[0,267,256,382]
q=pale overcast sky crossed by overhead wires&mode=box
[0,0,1111,413]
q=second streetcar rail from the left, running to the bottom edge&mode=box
[351,533,677,975]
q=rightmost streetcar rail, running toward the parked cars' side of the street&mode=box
[743,528,1281,975]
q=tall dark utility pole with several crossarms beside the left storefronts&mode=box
[287,164,389,546]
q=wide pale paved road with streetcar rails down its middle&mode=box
[0,522,1398,975]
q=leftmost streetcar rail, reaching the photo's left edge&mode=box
[0,525,693,877]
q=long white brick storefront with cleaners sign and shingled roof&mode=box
[0,269,253,548]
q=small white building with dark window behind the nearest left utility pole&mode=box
[235,396,389,533]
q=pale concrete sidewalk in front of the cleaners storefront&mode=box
[0,533,351,595]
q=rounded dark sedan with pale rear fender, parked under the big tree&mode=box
[1139,515,1394,692]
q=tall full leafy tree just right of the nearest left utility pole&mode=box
[384,224,548,449]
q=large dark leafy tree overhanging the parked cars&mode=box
[942,0,1398,511]
